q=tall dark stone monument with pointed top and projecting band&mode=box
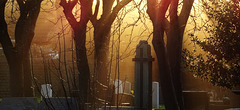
[133,41,154,110]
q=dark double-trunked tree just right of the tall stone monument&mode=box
[147,0,194,110]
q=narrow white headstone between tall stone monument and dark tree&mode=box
[152,82,159,108]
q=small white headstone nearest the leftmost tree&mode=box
[41,84,52,98]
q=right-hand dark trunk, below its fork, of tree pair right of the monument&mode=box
[167,19,184,110]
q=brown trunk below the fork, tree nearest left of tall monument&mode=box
[94,25,111,105]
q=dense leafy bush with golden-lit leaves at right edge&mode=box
[184,0,240,89]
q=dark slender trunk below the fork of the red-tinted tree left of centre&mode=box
[74,24,90,110]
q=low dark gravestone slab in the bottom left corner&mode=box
[0,97,38,110]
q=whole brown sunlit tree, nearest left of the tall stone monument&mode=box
[91,0,132,105]
